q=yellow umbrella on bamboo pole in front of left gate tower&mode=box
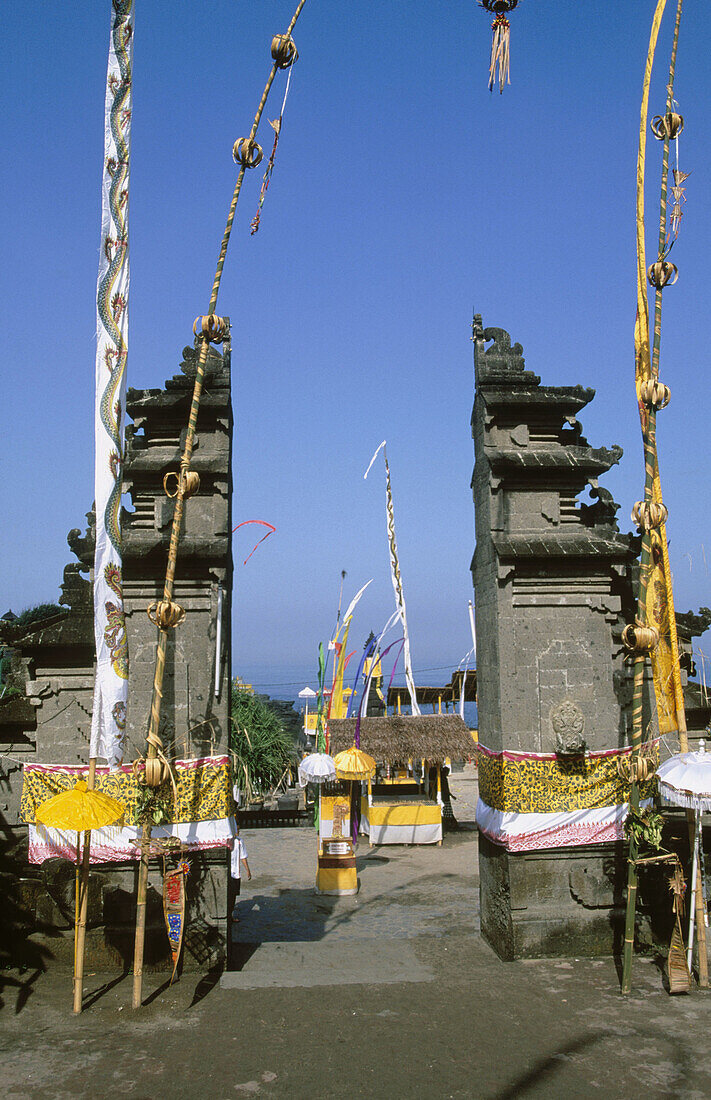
[34,779,125,1012]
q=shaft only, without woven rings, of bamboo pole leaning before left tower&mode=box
[133,0,306,1009]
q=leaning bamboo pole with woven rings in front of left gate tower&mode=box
[133,0,306,1009]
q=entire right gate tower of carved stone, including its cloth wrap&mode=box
[472,317,649,958]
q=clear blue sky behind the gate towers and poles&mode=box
[0,0,711,695]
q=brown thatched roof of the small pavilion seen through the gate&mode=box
[328,714,474,763]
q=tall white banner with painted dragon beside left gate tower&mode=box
[89,0,133,768]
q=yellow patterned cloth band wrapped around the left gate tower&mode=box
[20,756,234,825]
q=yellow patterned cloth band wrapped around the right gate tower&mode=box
[479,741,659,814]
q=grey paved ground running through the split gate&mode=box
[0,776,711,1100]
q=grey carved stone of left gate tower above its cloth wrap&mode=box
[122,332,232,756]
